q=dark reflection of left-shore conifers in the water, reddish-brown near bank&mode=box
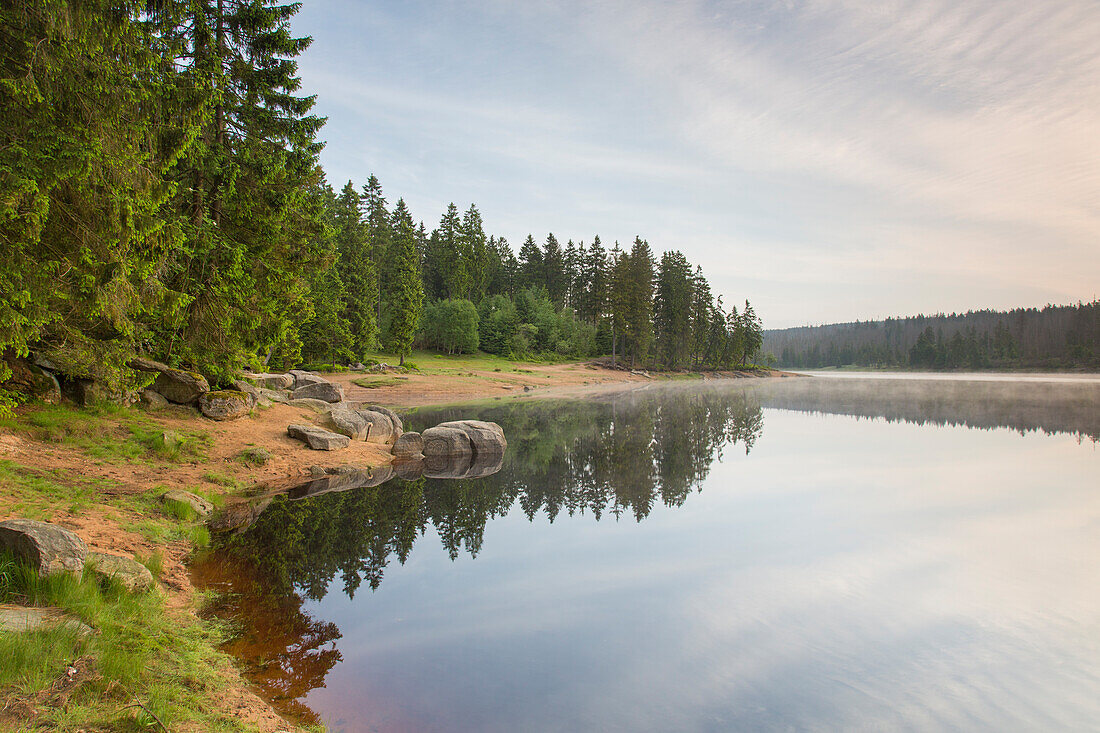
[193,391,763,722]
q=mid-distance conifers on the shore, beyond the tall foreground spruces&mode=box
[301,176,762,369]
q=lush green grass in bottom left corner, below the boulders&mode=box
[0,554,259,732]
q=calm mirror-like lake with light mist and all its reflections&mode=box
[194,373,1100,732]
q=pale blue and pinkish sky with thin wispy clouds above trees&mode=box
[293,0,1100,328]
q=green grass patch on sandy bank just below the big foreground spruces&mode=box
[0,404,212,463]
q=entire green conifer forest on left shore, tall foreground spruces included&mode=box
[0,0,760,413]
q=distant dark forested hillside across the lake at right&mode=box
[763,300,1100,370]
